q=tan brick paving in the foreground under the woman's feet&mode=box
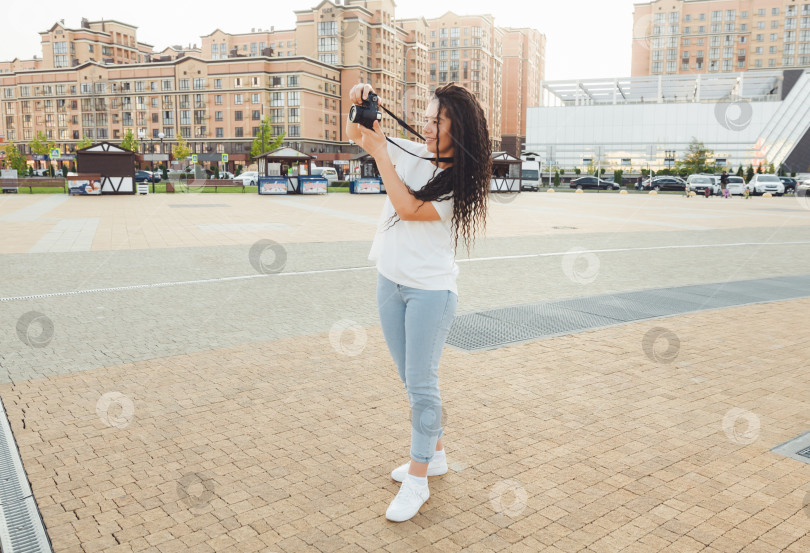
[0,300,810,553]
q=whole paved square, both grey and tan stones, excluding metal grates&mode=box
[0,194,810,553]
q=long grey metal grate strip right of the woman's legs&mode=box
[447,275,810,351]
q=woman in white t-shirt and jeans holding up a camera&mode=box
[346,83,492,522]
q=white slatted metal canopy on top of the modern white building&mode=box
[543,71,782,105]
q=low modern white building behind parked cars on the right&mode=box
[525,69,810,172]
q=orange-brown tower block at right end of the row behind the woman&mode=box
[500,28,546,157]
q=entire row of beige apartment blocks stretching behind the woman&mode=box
[0,0,545,163]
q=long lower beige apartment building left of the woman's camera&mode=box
[0,56,342,162]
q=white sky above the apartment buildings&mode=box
[0,0,633,80]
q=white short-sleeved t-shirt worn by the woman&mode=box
[368,138,458,295]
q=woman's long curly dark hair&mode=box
[382,83,492,254]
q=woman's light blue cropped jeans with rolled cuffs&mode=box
[377,273,458,463]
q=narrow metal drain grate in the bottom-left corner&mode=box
[0,399,53,553]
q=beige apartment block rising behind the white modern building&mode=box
[631,0,810,76]
